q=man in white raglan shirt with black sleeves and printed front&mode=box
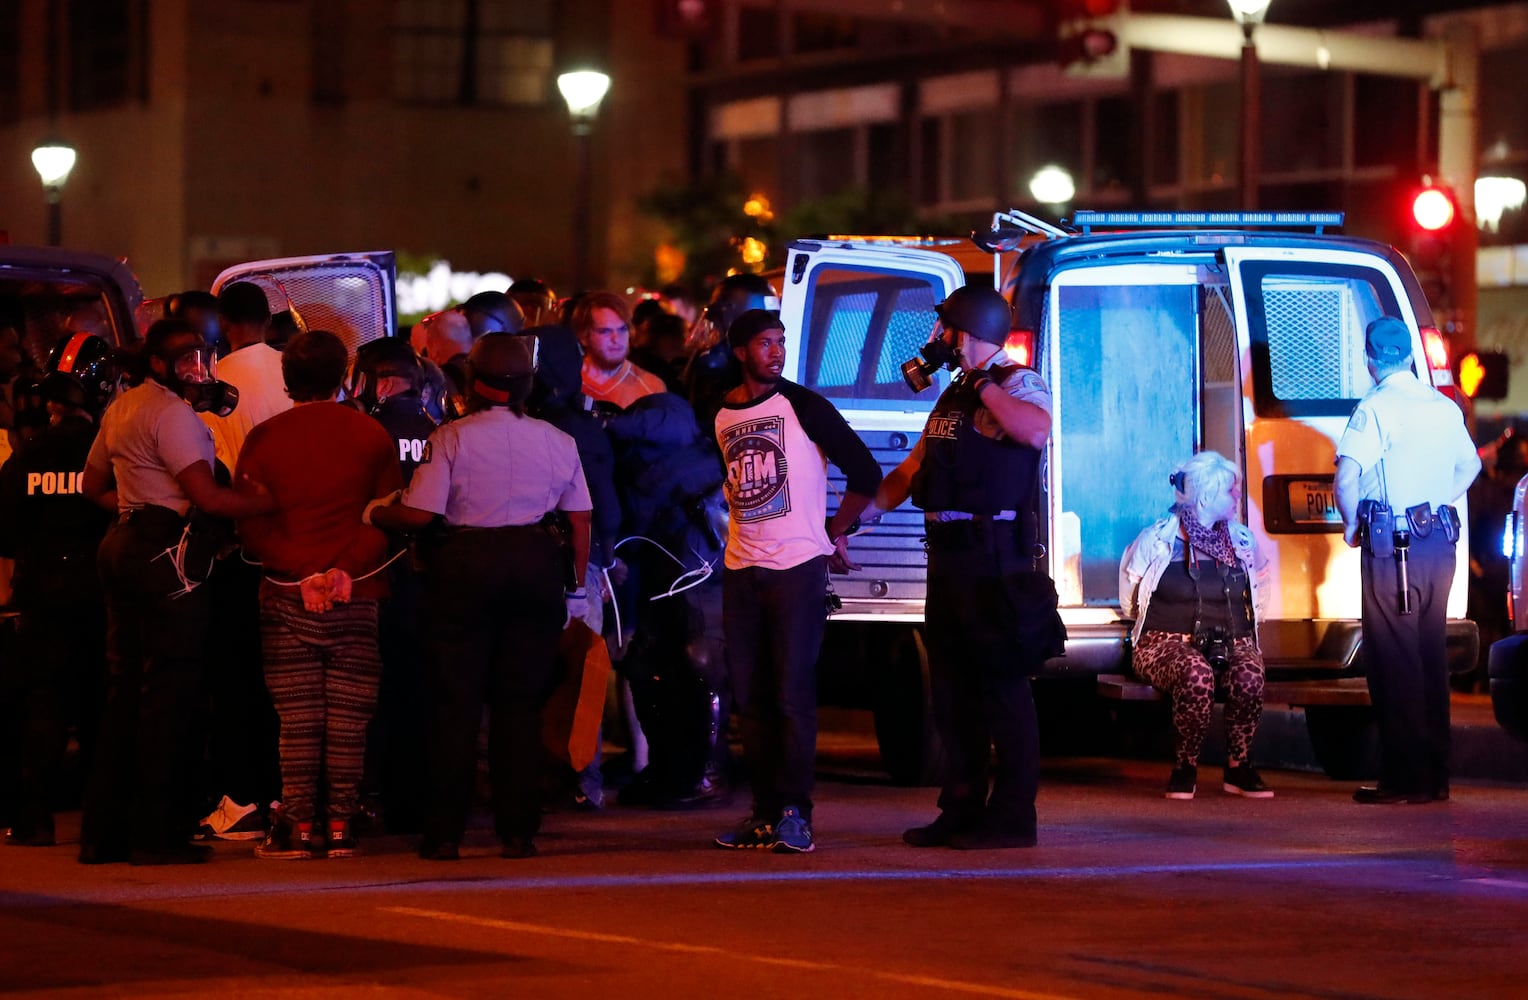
[705,309,880,853]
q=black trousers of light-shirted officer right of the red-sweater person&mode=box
[425,526,567,843]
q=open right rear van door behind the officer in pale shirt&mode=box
[1224,246,1468,619]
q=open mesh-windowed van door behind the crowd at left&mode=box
[212,251,397,355]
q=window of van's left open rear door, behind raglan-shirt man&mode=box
[801,266,949,410]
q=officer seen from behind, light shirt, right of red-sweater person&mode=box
[368,333,591,861]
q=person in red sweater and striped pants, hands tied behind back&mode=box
[235,330,402,859]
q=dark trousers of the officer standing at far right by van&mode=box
[1363,529,1455,794]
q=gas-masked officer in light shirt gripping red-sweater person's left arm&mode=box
[79,320,275,864]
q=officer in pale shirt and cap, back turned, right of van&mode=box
[1335,317,1481,804]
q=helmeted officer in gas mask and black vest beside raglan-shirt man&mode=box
[877,286,1065,849]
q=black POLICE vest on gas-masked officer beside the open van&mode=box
[911,379,1041,514]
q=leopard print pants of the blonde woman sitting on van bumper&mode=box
[1134,631,1262,766]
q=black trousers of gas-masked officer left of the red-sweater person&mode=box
[79,508,209,852]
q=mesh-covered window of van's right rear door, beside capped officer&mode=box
[1241,260,1400,416]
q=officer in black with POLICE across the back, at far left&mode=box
[0,333,118,847]
